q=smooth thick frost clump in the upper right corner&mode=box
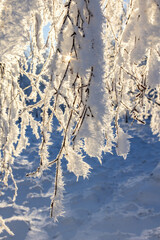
[122,0,160,63]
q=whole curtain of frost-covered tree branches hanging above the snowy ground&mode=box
[0,0,160,234]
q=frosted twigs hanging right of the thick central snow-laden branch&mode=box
[105,0,160,143]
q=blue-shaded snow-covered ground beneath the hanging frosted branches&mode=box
[0,123,160,240]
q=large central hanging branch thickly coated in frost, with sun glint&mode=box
[47,0,113,218]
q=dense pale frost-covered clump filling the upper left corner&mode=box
[0,0,48,62]
